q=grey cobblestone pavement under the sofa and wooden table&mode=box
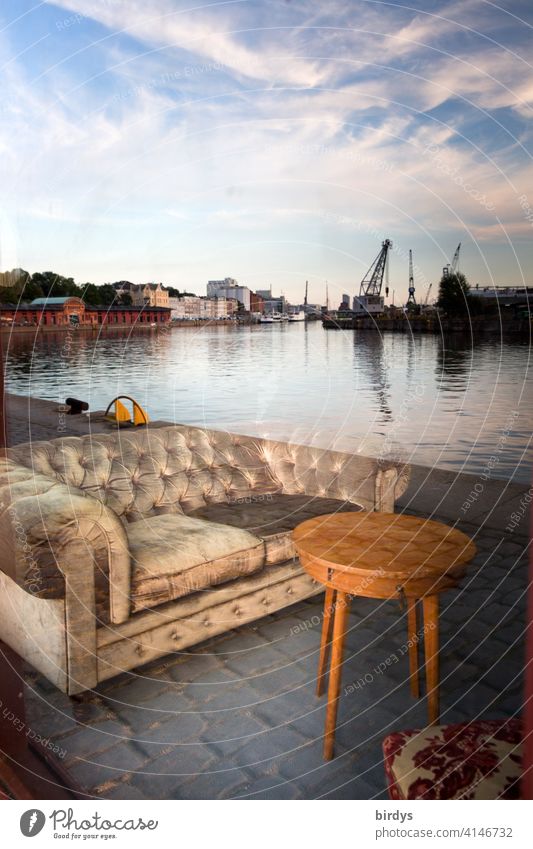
[23,525,527,799]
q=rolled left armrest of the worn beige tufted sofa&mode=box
[0,458,131,626]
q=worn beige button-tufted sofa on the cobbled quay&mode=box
[0,425,408,694]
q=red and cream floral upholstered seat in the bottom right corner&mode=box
[383,719,522,799]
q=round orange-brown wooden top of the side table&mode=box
[293,512,476,578]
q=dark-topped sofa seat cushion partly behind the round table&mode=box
[189,493,362,565]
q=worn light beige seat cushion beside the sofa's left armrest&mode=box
[126,514,265,613]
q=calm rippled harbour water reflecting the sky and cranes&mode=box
[4,322,533,483]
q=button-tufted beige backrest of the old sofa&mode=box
[8,425,407,522]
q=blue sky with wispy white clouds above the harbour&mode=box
[0,0,533,305]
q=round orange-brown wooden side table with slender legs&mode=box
[293,512,476,760]
